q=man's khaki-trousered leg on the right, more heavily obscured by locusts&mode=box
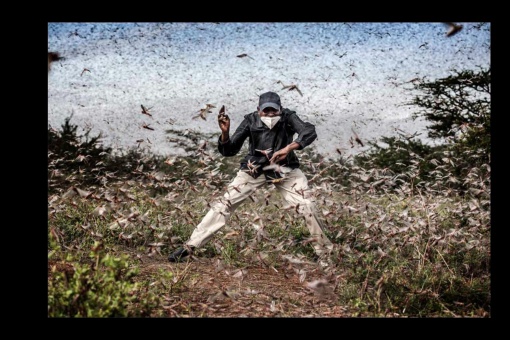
[276,168,333,256]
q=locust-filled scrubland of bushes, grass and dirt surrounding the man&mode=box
[48,70,491,317]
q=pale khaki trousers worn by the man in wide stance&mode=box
[186,168,332,256]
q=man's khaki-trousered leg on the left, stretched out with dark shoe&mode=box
[186,170,265,247]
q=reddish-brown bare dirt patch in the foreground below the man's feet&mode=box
[133,251,352,318]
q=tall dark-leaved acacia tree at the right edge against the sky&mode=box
[356,68,491,194]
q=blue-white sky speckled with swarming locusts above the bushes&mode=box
[48,22,491,158]
